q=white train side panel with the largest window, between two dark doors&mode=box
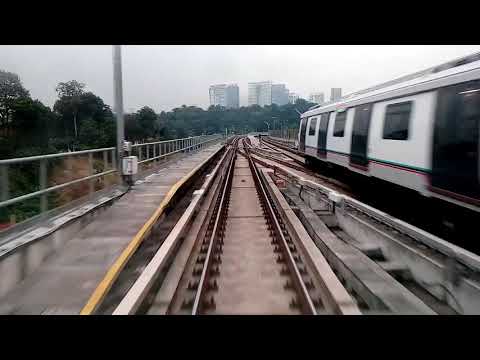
[368,92,436,195]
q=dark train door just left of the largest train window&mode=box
[350,104,372,170]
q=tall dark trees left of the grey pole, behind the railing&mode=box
[0,70,115,158]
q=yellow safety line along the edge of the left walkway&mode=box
[80,148,222,315]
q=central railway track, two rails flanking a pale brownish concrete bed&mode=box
[168,140,334,314]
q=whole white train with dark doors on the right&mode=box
[298,53,480,212]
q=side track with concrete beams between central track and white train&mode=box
[240,136,480,314]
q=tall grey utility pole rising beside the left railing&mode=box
[113,45,125,174]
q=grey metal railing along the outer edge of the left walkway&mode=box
[0,134,223,226]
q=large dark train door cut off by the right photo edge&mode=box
[431,80,480,204]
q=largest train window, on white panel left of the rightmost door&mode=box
[383,101,412,140]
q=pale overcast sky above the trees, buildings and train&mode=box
[0,45,480,112]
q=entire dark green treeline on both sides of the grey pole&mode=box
[0,70,313,159]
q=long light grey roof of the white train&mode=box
[301,53,480,118]
